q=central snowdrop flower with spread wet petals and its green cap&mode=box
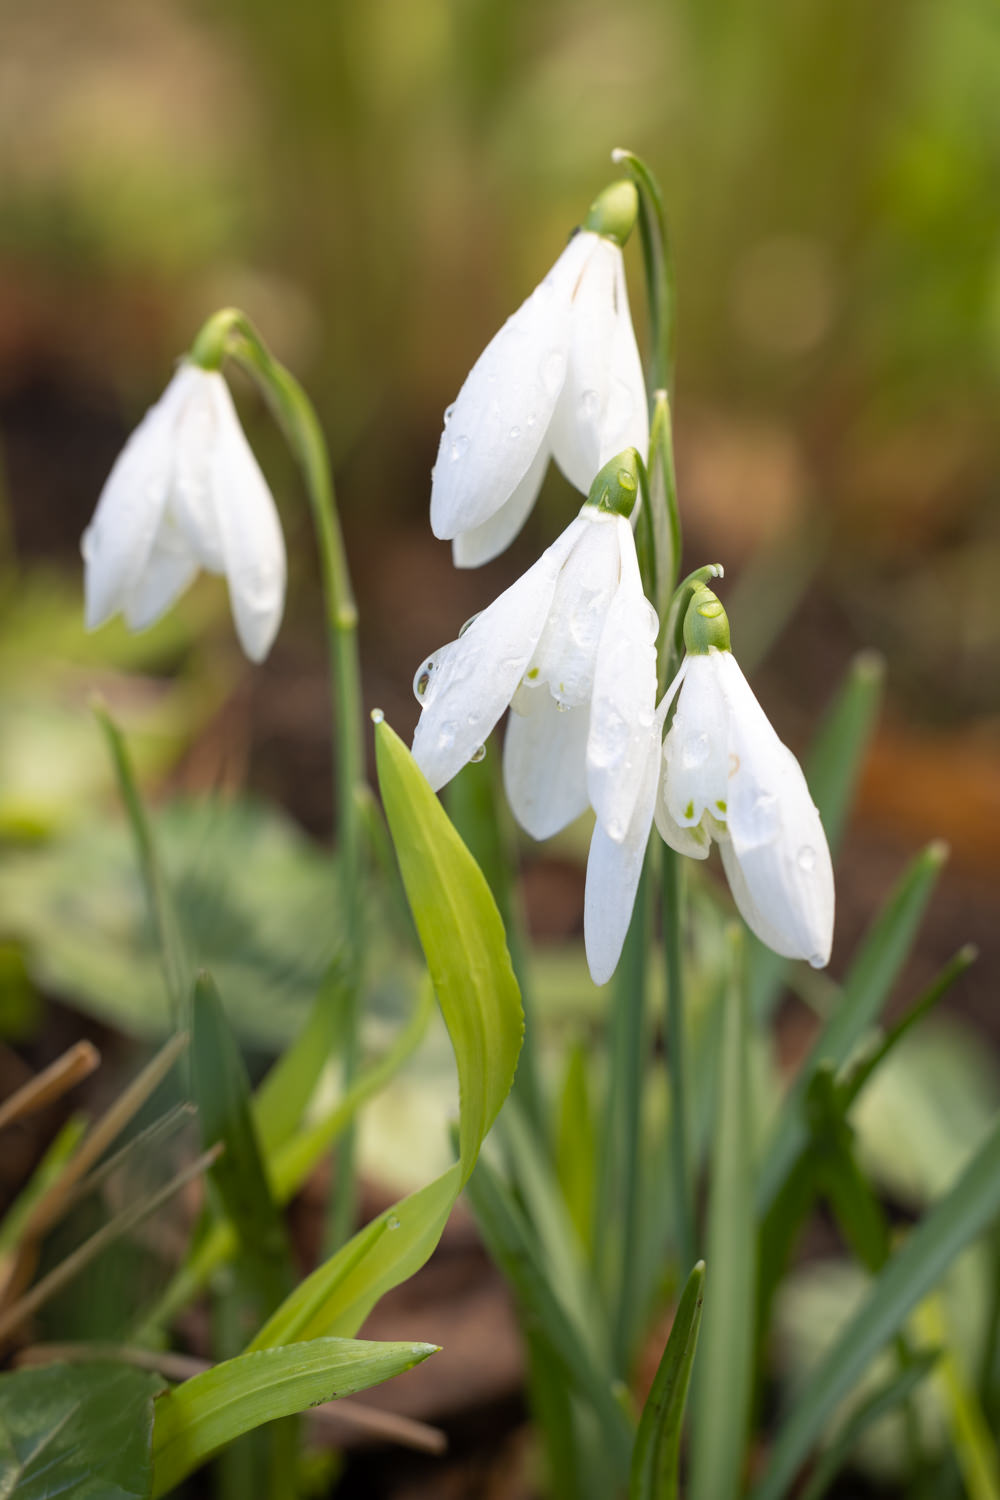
[414,450,663,983]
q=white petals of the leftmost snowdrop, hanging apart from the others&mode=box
[82,362,285,662]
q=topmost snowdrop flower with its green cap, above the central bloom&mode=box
[430,182,649,567]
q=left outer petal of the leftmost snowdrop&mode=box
[82,365,190,630]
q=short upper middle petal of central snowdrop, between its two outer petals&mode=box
[531,506,621,708]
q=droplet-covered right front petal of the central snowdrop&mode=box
[586,516,658,840]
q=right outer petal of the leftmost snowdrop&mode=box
[211,378,286,662]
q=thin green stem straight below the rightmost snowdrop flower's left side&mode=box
[661,845,696,1275]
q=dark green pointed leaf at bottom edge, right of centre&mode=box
[628,1260,705,1500]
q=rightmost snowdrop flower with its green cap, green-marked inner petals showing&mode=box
[655,588,834,968]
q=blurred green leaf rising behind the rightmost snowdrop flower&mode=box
[749,651,885,1022]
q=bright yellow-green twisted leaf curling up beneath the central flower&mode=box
[250,722,523,1349]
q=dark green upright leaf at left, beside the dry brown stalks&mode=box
[190,972,292,1313]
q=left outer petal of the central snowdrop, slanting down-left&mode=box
[412,518,583,791]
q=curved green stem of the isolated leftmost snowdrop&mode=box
[190,308,364,1245]
